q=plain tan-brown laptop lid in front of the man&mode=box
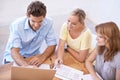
[11,66,56,80]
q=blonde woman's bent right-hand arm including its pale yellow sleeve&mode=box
[67,28,91,62]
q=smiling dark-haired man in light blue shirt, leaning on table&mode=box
[4,1,57,66]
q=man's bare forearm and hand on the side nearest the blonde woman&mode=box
[29,45,56,66]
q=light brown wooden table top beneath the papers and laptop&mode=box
[0,52,88,80]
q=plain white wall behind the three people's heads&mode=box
[0,0,120,26]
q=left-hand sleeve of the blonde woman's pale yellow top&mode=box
[60,23,68,41]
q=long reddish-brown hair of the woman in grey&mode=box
[95,22,120,61]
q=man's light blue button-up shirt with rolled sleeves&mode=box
[4,17,57,61]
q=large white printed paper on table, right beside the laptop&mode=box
[55,64,83,80]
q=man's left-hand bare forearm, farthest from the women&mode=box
[11,48,28,66]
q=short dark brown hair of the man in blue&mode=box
[27,1,47,17]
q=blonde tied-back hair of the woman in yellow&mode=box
[72,8,86,23]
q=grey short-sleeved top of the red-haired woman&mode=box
[95,52,120,80]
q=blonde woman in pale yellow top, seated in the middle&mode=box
[55,8,91,65]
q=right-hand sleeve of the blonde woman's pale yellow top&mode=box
[80,29,92,50]
